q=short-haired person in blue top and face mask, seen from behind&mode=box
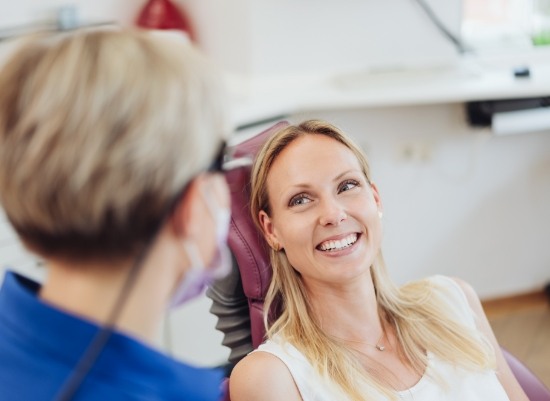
[0,30,230,401]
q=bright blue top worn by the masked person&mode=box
[0,272,223,401]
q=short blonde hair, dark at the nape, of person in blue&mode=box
[0,30,228,259]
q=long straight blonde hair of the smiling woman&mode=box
[251,120,495,401]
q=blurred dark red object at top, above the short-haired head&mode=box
[136,0,194,40]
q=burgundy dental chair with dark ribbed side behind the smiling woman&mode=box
[207,121,550,401]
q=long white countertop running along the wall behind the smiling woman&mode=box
[231,47,550,125]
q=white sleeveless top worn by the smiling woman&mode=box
[253,276,509,401]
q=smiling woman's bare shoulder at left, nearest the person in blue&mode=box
[229,351,302,401]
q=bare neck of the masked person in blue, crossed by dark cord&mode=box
[39,247,176,343]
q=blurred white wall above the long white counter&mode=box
[186,0,462,76]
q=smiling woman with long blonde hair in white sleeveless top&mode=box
[230,121,527,401]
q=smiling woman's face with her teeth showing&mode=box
[260,135,382,284]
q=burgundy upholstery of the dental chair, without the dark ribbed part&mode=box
[225,121,550,401]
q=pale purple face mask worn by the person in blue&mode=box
[170,197,231,308]
